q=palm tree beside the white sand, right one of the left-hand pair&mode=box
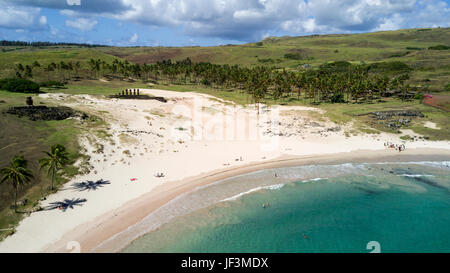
[39,144,69,190]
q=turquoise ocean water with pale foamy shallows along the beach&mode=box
[122,162,450,252]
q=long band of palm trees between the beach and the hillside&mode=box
[10,58,418,104]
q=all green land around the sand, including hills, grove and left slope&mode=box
[0,28,450,238]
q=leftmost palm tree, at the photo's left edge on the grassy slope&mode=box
[0,156,33,212]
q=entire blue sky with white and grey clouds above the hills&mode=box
[0,0,450,46]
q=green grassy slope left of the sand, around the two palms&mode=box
[0,90,104,240]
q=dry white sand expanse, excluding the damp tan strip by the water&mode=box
[0,90,450,252]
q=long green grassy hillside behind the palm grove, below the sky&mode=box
[0,28,450,91]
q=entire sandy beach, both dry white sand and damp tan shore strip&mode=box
[0,90,450,252]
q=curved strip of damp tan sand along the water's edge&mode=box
[44,148,450,252]
